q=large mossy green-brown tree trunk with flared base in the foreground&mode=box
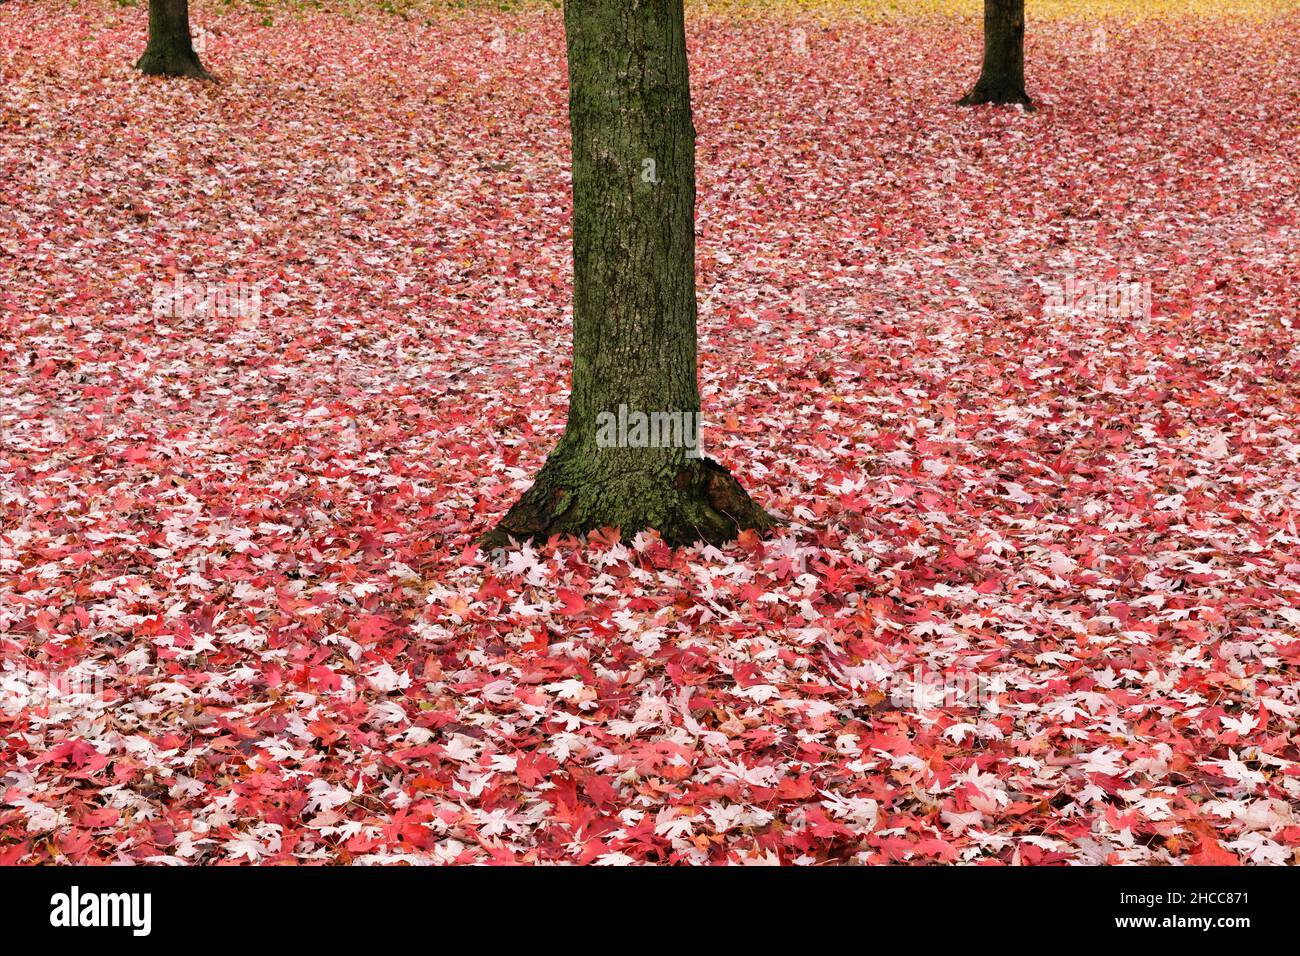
[481,0,774,545]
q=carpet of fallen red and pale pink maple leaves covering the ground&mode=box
[0,0,1300,864]
